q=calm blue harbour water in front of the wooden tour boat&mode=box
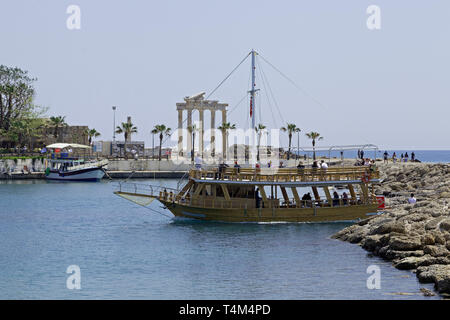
[0,180,437,299]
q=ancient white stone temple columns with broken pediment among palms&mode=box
[177,92,228,158]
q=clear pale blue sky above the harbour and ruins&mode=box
[0,0,450,149]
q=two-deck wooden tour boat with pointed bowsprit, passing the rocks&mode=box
[114,167,383,222]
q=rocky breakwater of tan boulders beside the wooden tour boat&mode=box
[333,163,450,294]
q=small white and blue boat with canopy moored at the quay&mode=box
[45,143,108,181]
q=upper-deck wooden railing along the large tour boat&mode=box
[189,167,380,182]
